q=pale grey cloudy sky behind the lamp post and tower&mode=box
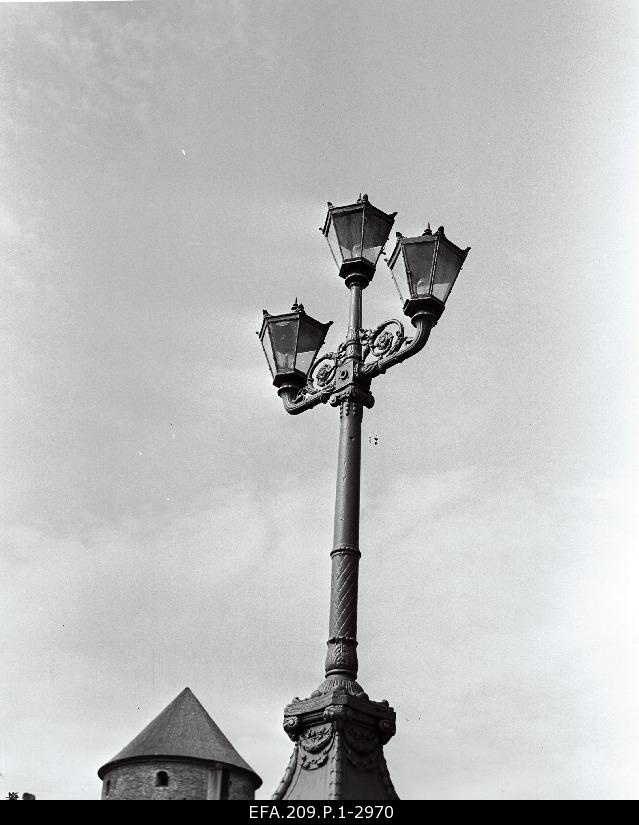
[0,0,639,799]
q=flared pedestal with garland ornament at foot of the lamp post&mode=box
[273,679,398,800]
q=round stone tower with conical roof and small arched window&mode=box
[98,688,262,799]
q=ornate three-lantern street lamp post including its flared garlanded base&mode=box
[259,195,468,800]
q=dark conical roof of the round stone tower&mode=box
[98,687,262,788]
